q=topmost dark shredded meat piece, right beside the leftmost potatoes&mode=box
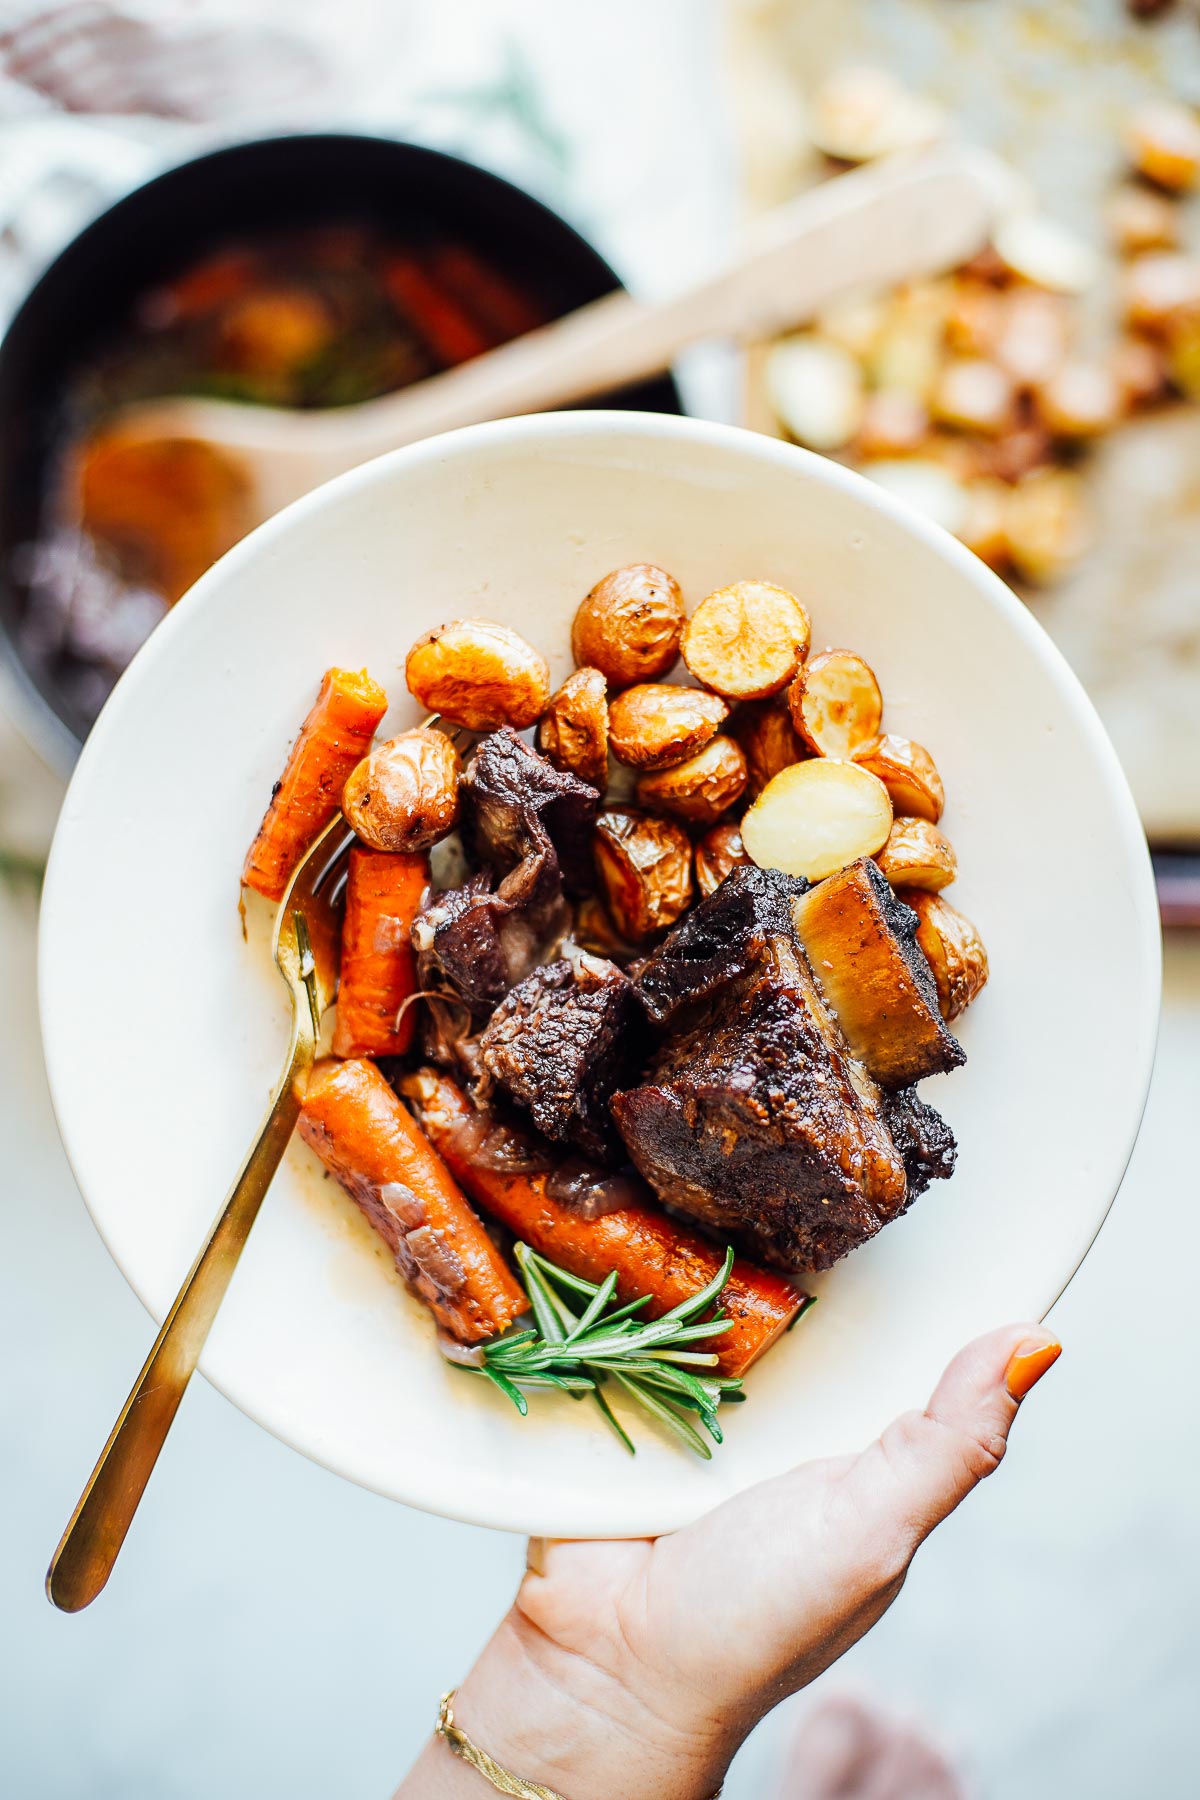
[462,725,601,895]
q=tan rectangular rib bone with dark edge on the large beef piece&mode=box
[791,857,966,1091]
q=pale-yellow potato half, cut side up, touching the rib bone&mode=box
[741,758,892,882]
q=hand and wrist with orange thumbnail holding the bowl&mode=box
[398,1325,1060,1800]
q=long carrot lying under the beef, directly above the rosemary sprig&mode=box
[401,1069,804,1375]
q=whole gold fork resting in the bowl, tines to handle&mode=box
[45,814,354,1613]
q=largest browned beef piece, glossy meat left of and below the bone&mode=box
[612,869,907,1269]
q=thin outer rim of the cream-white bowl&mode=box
[38,409,1162,1535]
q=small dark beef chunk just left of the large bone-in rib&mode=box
[479,952,640,1159]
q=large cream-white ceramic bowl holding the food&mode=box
[41,412,1159,1535]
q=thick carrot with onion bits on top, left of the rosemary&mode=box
[300,1058,529,1345]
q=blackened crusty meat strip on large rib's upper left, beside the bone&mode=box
[635,864,808,1026]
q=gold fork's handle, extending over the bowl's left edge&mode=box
[45,1017,315,1613]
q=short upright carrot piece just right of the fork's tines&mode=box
[333,848,430,1057]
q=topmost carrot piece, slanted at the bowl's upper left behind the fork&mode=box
[241,670,387,900]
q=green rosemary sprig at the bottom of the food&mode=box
[479,1244,745,1458]
